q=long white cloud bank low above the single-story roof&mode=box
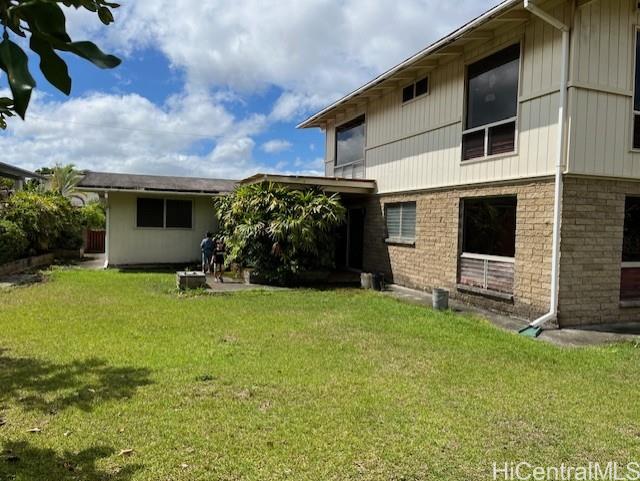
[0,89,265,178]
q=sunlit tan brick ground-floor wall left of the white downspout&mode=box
[364,179,554,319]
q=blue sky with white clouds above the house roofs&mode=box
[0,0,498,178]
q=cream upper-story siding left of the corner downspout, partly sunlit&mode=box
[326,3,572,193]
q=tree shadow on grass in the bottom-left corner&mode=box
[0,442,142,481]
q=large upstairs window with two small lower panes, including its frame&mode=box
[462,44,520,160]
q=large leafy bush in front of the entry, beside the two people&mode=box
[214,184,346,284]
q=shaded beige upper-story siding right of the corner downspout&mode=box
[567,0,640,179]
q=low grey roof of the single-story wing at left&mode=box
[78,171,237,194]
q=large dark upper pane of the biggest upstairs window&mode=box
[467,45,520,129]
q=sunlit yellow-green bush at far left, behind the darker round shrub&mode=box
[1,191,83,252]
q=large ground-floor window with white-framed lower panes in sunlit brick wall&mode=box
[459,197,517,294]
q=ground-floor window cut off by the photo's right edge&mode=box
[620,197,640,300]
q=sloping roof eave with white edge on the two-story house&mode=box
[298,0,529,128]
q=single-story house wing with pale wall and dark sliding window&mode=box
[78,172,236,267]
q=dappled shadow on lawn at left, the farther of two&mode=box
[0,349,151,414]
